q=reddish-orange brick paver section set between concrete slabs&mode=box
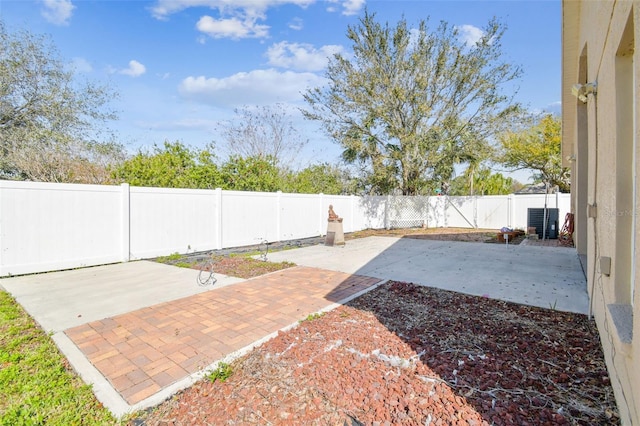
[65,267,379,404]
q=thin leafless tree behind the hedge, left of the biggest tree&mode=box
[219,104,307,166]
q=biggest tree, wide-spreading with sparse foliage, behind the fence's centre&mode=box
[303,12,520,195]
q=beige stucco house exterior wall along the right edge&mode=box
[562,0,640,425]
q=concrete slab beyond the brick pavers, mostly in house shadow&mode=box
[269,237,589,314]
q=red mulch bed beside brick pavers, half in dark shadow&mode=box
[131,282,619,425]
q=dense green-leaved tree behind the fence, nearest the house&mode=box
[498,114,571,192]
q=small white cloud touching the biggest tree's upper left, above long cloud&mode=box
[266,41,344,71]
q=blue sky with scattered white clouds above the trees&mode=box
[0,0,561,178]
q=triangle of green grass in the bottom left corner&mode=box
[0,291,117,426]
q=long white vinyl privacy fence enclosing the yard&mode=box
[0,181,570,277]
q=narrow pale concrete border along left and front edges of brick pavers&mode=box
[112,280,389,419]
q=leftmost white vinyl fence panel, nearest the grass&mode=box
[0,181,124,276]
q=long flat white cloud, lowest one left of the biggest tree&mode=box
[178,69,324,106]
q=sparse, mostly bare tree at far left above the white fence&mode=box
[0,21,123,183]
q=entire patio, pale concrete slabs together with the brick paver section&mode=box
[0,237,589,416]
